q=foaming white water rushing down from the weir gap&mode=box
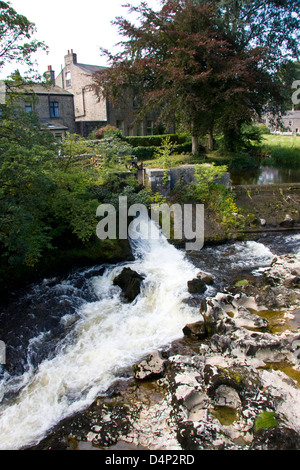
[0,218,200,450]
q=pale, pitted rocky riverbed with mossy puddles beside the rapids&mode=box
[29,250,300,450]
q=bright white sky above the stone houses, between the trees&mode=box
[1,0,160,78]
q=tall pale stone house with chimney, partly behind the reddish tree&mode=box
[55,49,161,137]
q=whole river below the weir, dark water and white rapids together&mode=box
[0,218,300,450]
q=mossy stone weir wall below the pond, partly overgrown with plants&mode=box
[139,165,300,242]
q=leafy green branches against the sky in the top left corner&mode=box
[0,1,46,69]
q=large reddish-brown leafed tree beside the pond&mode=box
[95,0,300,153]
